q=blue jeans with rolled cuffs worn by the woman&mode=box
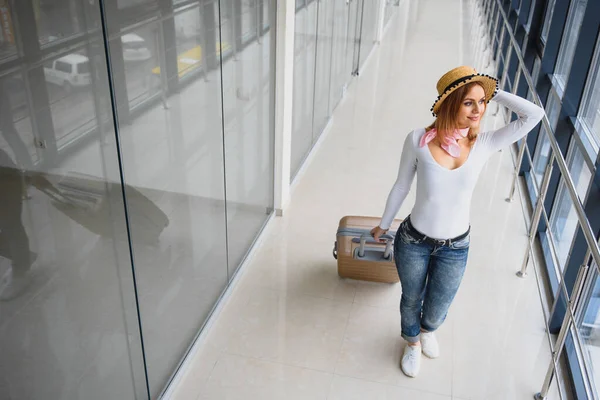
[394,219,470,343]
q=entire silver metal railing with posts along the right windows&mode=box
[471,0,600,400]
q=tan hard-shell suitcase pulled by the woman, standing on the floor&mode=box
[333,216,402,283]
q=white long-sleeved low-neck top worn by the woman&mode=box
[379,90,544,239]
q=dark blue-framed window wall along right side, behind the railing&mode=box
[486,0,600,398]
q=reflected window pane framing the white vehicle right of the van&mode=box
[120,23,164,109]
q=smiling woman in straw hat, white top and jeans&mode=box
[371,66,544,377]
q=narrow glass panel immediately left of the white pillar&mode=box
[221,0,275,276]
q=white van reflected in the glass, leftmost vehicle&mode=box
[44,54,91,92]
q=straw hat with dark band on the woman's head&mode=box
[430,66,498,117]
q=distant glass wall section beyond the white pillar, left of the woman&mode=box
[291,0,378,177]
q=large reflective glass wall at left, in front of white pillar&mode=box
[0,0,275,399]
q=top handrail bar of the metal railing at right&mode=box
[496,0,600,272]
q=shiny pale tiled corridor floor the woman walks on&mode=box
[168,0,558,400]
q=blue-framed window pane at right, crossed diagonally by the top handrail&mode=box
[550,141,592,270]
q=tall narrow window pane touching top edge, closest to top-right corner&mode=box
[555,0,587,88]
